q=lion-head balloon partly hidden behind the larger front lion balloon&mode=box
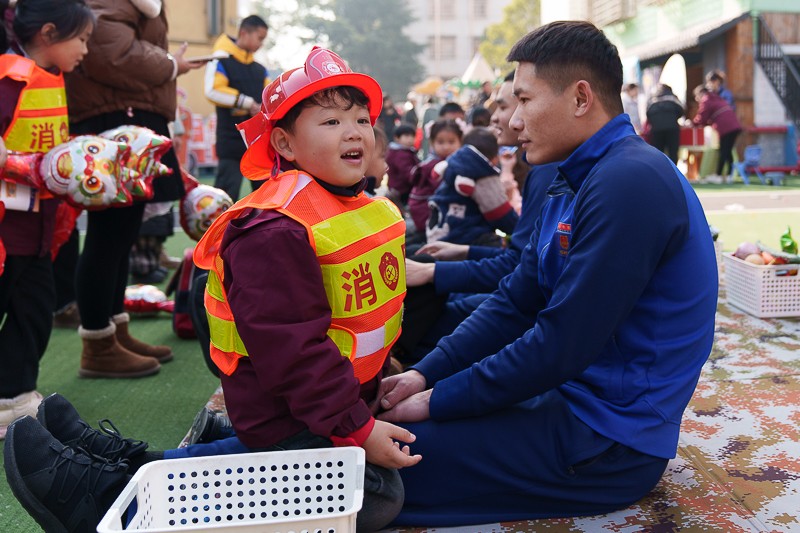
[100,125,172,200]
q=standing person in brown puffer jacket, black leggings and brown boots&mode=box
[66,0,203,378]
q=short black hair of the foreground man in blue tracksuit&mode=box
[506,20,622,115]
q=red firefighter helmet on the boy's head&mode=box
[237,46,383,179]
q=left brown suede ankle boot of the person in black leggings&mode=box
[78,322,161,378]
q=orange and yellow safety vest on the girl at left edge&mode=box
[0,54,69,198]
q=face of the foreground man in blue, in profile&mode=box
[509,62,582,165]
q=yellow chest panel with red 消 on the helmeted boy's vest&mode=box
[321,235,406,318]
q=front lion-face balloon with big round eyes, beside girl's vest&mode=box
[40,135,138,210]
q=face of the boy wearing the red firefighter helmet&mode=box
[273,101,375,187]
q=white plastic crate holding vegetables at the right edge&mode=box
[722,253,800,318]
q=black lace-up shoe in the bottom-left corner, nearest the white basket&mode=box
[5,416,130,533]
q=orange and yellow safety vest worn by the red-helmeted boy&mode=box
[194,170,406,383]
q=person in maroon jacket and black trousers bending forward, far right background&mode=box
[692,85,742,183]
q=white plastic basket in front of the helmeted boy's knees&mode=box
[97,447,365,533]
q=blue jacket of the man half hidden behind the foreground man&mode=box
[433,163,558,294]
